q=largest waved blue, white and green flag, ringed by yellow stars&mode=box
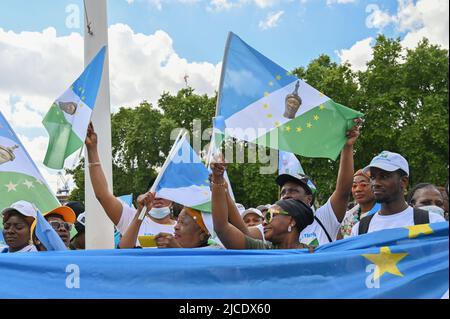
[217,33,363,160]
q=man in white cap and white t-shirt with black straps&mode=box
[351,151,445,236]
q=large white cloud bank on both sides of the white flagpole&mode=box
[0,24,221,189]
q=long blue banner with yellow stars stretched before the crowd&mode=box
[0,222,449,299]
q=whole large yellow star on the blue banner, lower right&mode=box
[362,246,408,280]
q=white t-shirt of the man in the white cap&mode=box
[351,206,445,236]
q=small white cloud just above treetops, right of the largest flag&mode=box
[336,38,374,71]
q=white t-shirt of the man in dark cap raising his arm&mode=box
[299,198,341,247]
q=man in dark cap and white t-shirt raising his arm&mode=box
[276,120,360,247]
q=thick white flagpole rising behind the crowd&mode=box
[84,0,114,249]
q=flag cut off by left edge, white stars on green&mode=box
[0,112,60,212]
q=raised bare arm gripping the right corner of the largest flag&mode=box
[330,119,361,222]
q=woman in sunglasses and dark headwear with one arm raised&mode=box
[210,160,314,249]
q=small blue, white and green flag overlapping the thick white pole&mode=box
[42,47,106,169]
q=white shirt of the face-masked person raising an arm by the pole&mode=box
[116,202,176,246]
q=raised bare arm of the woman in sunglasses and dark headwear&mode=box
[211,163,245,249]
